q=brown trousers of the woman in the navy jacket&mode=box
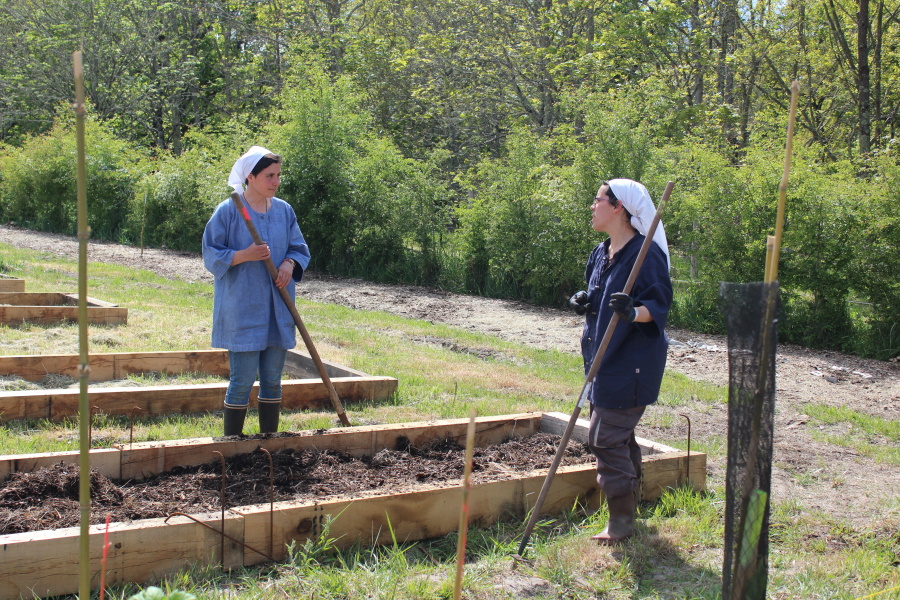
[588,406,647,498]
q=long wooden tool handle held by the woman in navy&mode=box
[519,181,672,556]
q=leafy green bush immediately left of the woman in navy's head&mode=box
[456,132,598,304]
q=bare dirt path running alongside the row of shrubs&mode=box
[0,226,900,526]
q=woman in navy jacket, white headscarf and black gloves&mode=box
[569,179,672,544]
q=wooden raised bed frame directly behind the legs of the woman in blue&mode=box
[0,350,397,422]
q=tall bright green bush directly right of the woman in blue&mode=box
[272,57,447,283]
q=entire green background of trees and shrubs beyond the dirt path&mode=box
[0,0,900,358]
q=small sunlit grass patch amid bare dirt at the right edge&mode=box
[803,404,900,465]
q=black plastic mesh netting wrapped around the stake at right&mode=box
[719,282,779,600]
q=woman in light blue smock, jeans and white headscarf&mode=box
[203,146,310,435]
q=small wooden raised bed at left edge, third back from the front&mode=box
[0,292,128,325]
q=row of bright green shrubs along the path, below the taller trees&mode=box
[0,79,900,358]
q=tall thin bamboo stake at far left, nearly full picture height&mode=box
[72,51,91,598]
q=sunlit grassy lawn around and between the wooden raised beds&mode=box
[0,244,900,600]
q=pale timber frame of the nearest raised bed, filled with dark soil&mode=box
[0,413,706,600]
